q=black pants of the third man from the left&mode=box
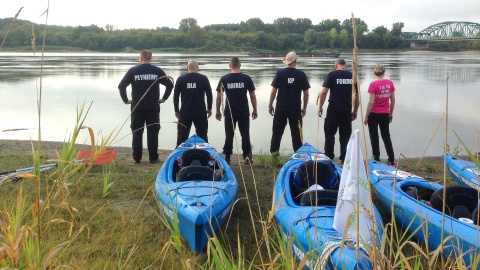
[223,117,252,158]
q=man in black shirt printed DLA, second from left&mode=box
[173,60,213,147]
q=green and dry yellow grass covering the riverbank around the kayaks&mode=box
[0,141,476,269]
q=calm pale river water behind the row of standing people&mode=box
[0,52,480,158]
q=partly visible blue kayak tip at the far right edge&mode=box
[442,155,479,189]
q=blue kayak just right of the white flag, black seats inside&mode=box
[368,159,480,269]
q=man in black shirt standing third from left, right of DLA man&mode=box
[215,57,258,164]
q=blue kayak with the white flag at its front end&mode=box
[274,143,382,269]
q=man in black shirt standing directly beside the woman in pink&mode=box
[318,59,359,165]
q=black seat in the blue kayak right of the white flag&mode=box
[430,186,478,218]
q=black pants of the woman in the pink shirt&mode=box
[368,113,395,163]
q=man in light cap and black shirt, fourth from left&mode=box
[268,52,310,154]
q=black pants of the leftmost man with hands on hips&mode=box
[130,109,160,161]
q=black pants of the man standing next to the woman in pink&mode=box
[323,102,352,161]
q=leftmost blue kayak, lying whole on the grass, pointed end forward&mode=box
[155,135,238,254]
